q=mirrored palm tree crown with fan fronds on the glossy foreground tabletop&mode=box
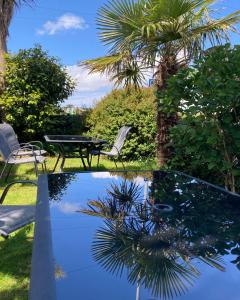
[82,181,224,298]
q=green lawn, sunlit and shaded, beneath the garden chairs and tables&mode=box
[0,157,156,300]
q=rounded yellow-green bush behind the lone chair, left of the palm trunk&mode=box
[88,89,156,159]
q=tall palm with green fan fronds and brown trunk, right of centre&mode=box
[82,0,240,165]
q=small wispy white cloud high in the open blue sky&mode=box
[37,13,88,35]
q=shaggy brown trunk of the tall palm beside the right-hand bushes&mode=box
[156,55,179,166]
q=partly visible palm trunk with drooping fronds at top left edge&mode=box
[0,0,33,91]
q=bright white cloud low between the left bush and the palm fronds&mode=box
[65,65,113,107]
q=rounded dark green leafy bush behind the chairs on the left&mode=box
[0,46,74,141]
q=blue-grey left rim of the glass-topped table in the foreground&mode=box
[29,175,56,300]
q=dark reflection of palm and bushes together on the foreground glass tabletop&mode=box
[81,172,240,298]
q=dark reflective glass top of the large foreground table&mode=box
[48,171,240,300]
